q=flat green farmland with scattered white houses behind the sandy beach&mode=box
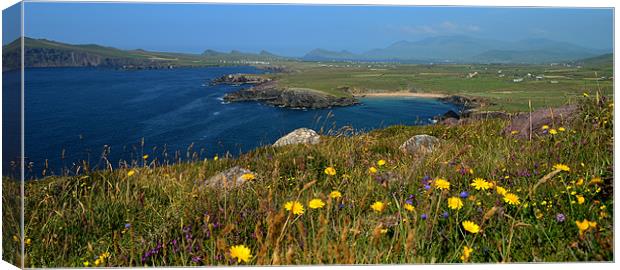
[270,55,613,111]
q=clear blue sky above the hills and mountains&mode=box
[18,2,613,56]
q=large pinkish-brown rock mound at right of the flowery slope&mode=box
[503,105,578,138]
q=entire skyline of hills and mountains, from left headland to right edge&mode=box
[2,36,611,70]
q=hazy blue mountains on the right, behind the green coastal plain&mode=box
[303,36,611,63]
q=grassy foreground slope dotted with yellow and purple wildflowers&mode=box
[3,95,614,267]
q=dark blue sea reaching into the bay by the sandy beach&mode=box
[18,67,454,177]
